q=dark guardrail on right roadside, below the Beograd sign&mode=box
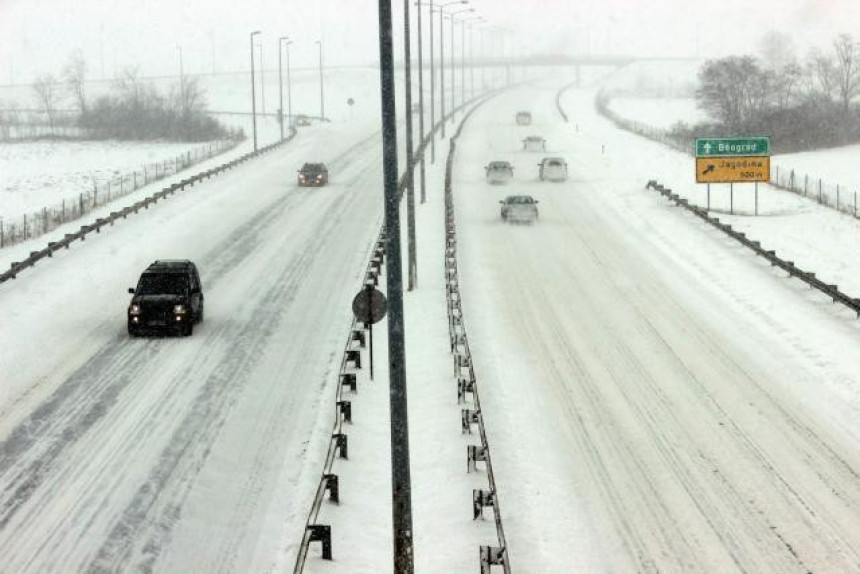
[645,180,860,318]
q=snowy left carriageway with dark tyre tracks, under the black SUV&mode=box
[0,123,381,572]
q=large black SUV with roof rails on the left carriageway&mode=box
[128,260,203,337]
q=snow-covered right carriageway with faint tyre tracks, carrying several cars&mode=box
[454,82,860,572]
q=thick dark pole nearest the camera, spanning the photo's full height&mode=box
[379,0,413,574]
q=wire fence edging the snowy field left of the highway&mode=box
[0,139,241,248]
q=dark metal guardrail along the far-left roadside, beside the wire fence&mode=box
[0,129,297,283]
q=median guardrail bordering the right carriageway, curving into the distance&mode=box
[445,100,511,574]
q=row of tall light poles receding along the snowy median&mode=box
[379,0,510,574]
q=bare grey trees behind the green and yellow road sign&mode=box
[673,32,860,152]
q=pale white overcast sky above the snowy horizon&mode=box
[0,0,860,84]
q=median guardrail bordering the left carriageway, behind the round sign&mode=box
[293,92,508,574]
